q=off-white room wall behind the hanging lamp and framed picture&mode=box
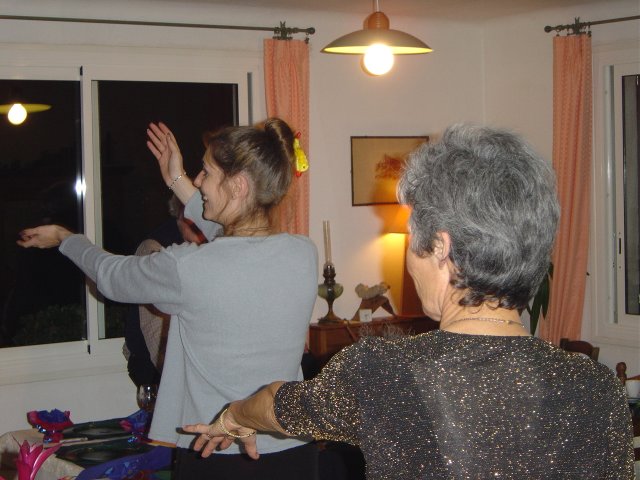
[0,0,637,432]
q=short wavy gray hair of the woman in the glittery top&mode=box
[398,124,560,308]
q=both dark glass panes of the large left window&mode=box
[0,80,238,347]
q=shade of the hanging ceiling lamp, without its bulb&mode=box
[322,12,433,55]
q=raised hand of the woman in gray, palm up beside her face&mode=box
[147,122,196,204]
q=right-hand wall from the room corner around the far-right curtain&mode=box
[483,0,640,375]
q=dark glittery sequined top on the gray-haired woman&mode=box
[275,330,634,480]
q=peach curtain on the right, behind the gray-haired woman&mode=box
[540,35,592,344]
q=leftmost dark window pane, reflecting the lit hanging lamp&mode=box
[0,80,86,347]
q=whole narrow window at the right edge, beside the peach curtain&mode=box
[590,45,640,346]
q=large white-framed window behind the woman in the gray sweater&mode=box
[0,47,261,384]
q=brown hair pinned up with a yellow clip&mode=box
[204,118,295,219]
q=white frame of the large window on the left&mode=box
[0,45,264,385]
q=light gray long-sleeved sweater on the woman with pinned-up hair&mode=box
[60,194,318,454]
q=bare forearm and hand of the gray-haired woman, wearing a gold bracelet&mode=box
[183,382,289,459]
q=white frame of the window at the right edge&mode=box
[587,42,640,347]
